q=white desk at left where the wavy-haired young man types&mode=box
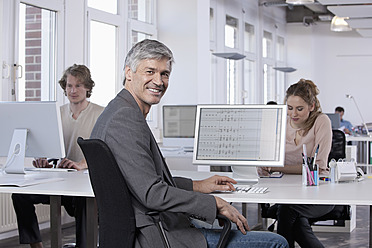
[0,171,98,248]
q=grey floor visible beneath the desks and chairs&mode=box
[0,204,369,248]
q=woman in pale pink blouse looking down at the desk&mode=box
[260,79,334,248]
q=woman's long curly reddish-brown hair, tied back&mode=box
[285,78,322,136]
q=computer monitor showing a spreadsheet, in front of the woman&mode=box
[193,105,287,183]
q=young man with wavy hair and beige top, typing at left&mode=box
[12,64,104,248]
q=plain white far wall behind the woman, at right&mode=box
[287,23,372,125]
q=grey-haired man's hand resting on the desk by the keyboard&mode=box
[193,175,236,193]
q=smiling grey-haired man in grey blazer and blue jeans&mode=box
[91,40,287,247]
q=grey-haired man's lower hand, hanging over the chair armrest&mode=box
[214,196,250,234]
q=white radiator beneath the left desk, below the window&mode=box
[0,193,49,233]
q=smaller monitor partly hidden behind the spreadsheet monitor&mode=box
[163,105,196,151]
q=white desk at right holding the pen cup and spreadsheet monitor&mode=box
[172,171,372,247]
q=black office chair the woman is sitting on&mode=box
[261,129,351,231]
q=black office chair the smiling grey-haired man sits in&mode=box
[77,137,231,248]
